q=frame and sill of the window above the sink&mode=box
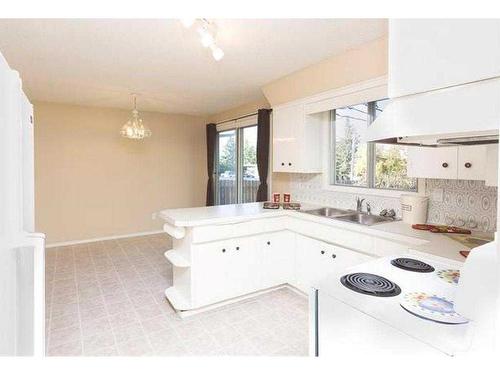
[325,98,423,197]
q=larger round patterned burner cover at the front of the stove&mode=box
[400,292,468,324]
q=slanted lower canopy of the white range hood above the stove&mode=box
[368,78,500,146]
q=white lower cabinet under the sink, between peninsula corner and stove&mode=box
[294,235,373,292]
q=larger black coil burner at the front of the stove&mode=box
[340,273,401,297]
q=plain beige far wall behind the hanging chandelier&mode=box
[34,103,206,244]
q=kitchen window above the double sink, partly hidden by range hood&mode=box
[331,99,417,191]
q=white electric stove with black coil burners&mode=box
[311,251,472,356]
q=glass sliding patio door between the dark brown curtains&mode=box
[215,125,260,204]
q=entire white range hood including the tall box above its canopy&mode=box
[367,19,500,147]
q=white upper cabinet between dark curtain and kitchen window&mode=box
[273,104,322,173]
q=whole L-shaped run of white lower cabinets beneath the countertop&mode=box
[191,231,371,308]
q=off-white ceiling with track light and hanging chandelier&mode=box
[0,19,387,115]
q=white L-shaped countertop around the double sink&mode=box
[158,203,490,262]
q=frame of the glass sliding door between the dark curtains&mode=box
[214,123,258,206]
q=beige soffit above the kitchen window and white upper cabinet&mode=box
[262,37,387,107]
